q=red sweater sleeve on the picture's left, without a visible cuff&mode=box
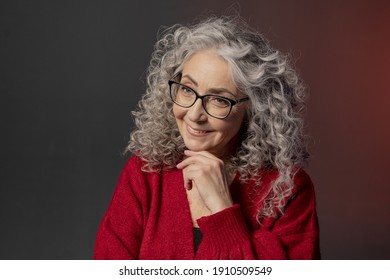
[94,158,147,259]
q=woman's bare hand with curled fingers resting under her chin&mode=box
[177,150,233,214]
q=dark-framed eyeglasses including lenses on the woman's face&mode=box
[168,73,249,119]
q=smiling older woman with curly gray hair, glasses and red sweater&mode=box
[94,17,320,260]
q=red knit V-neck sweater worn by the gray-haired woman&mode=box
[94,156,320,260]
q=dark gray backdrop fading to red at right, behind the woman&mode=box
[0,0,390,259]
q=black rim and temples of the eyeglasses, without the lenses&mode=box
[168,73,249,119]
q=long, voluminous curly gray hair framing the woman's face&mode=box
[126,17,308,222]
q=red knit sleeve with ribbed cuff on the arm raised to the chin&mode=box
[197,171,320,259]
